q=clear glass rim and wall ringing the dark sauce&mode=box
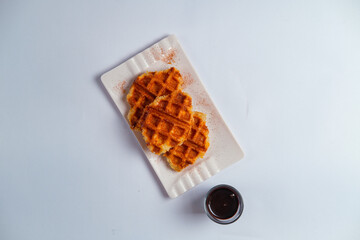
[204,184,244,224]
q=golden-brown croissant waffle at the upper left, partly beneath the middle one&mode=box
[126,67,183,130]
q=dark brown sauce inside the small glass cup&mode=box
[206,187,239,219]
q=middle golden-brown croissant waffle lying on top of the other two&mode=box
[141,90,193,154]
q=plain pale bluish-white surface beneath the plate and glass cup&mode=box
[0,0,360,240]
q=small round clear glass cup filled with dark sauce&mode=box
[204,184,244,224]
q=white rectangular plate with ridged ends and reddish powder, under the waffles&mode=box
[101,35,244,198]
